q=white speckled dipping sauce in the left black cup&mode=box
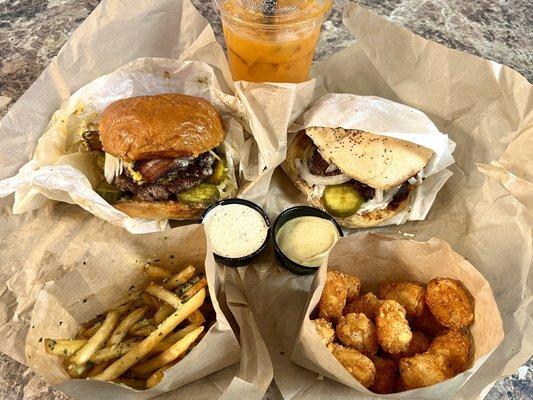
[203,204,268,258]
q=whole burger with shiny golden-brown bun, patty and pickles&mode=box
[84,93,236,220]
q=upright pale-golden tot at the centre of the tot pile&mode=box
[376,300,413,354]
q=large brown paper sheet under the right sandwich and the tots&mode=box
[231,3,533,400]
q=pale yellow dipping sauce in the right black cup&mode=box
[276,216,340,267]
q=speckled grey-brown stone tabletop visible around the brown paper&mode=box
[0,0,533,400]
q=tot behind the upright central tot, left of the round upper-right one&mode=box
[379,282,426,318]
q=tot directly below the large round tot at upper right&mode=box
[429,331,470,374]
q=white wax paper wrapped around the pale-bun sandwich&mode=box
[284,93,455,226]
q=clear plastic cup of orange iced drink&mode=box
[214,0,332,82]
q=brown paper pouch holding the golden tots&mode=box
[291,233,504,399]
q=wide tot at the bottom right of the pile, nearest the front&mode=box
[398,352,453,390]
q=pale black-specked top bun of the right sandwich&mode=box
[305,127,433,190]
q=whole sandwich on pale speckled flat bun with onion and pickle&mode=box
[284,127,433,228]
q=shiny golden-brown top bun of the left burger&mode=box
[99,93,225,162]
